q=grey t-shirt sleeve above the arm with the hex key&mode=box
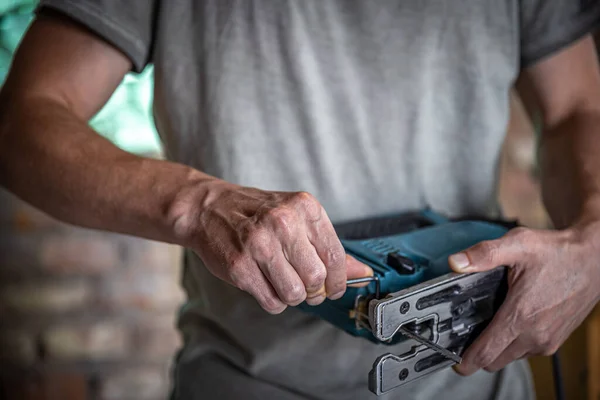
[36,0,158,72]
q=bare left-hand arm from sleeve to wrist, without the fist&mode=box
[0,12,208,242]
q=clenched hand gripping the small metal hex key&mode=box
[175,180,373,314]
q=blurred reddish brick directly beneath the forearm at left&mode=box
[40,234,121,274]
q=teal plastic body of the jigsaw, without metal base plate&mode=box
[298,210,510,344]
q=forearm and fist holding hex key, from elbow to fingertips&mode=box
[0,95,373,313]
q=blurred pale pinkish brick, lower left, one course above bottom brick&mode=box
[42,321,130,360]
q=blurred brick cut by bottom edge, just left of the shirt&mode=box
[100,367,169,400]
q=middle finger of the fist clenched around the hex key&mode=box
[282,236,327,306]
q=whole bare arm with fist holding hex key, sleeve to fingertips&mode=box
[0,11,372,313]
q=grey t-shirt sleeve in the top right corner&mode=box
[520,0,600,68]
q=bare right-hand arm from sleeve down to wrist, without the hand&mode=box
[518,36,600,228]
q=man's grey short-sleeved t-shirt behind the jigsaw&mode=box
[36,0,600,399]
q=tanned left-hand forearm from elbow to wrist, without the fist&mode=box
[0,97,211,243]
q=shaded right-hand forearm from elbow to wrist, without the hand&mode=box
[539,108,600,229]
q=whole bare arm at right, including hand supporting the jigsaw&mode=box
[450,36,600,375]
